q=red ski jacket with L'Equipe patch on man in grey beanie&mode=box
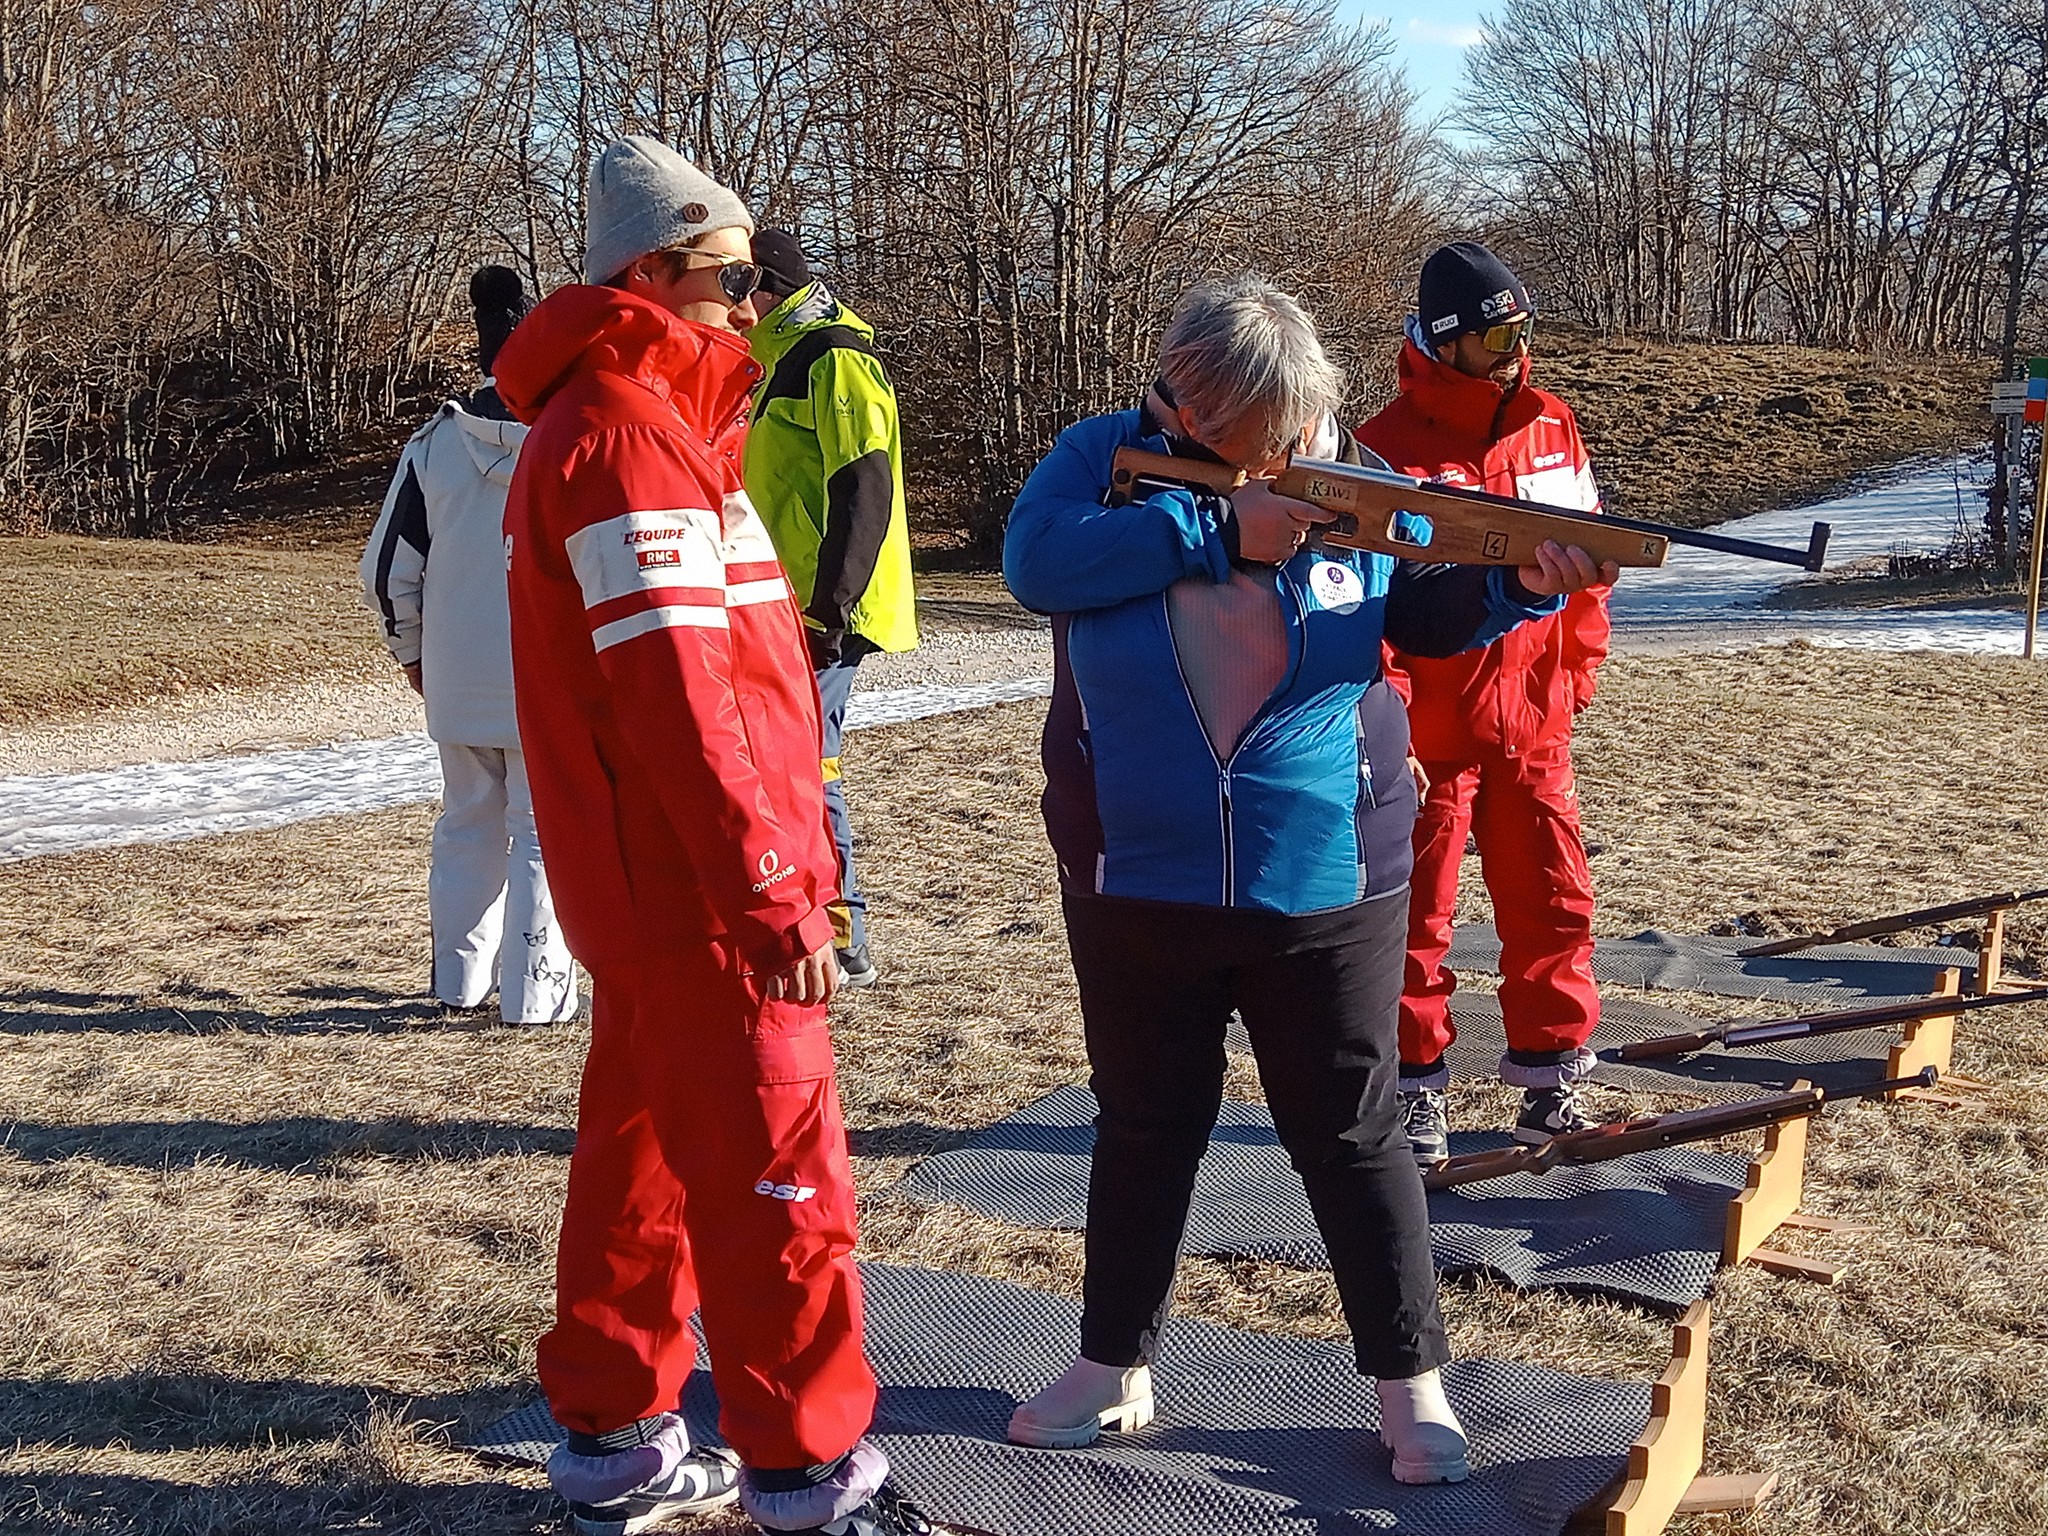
[496,287,838,987]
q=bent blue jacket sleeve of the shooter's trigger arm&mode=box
[1004,416,1231,612]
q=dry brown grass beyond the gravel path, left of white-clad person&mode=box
[0,528,391,725]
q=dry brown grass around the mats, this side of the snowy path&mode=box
[0,649,2048,1536]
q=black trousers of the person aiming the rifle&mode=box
[1065,891,1450,1378]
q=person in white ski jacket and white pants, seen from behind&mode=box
[362,266,578,1024]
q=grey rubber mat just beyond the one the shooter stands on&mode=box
[897,1087,1749,1313]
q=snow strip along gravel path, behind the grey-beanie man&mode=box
[0,676,1053,862]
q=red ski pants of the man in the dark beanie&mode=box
[1401,741,1599,1067]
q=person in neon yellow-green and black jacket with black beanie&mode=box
[745,229,918,987]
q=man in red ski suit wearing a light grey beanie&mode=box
[498,137,926,1536]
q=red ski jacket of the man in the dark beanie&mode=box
[1358,338,1608,762]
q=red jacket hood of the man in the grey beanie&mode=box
[494,283,762,440]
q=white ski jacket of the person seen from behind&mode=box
[362,389,526,748]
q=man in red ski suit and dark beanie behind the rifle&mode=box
[1358,242,1608,1161]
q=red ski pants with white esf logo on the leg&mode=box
[539,944,874,1468]
